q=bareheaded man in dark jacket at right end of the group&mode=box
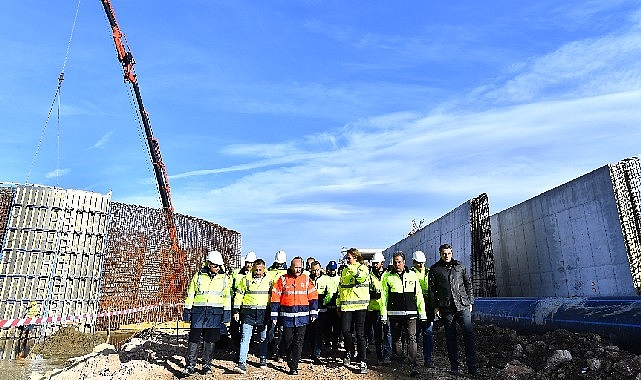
[428,244,479,375]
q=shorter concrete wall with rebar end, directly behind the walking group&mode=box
[383,194,496,297]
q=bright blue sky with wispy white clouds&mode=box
[0,0,641,268]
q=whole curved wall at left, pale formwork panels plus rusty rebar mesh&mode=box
[0,184,242,333]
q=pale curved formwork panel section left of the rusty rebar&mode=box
[0,185,110,331]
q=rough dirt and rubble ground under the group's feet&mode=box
[18,325,641,380]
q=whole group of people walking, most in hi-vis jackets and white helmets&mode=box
[183,244,479,376]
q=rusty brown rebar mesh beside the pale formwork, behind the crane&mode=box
[98,202,241,328]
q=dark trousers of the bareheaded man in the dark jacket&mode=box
[442,308,477,371]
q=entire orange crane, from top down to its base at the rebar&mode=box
[100,0,185,295]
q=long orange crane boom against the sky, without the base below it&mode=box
[100,0,179,251]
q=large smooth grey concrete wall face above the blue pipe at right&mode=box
[490,166,636,297]
